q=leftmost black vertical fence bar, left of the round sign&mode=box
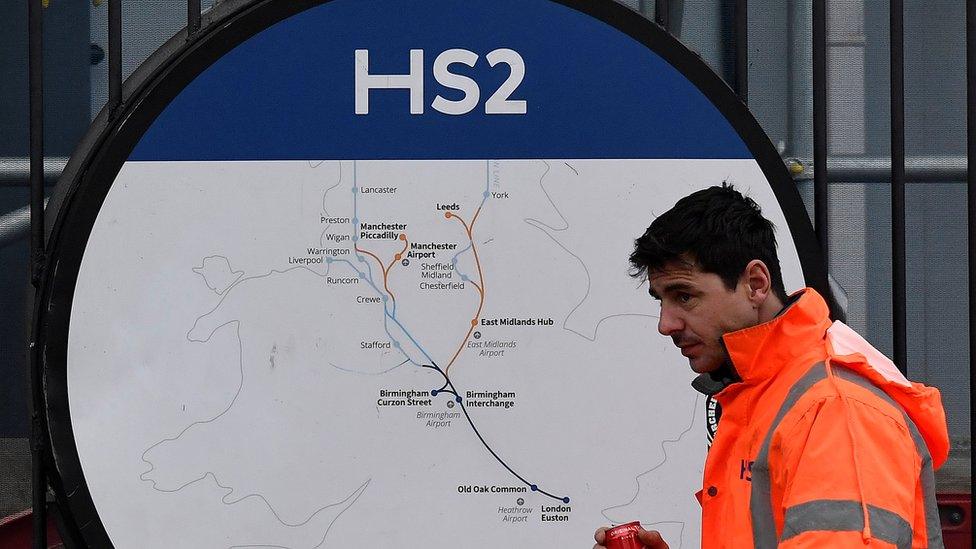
[27,0,47,549]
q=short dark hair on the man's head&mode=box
[630,183,786,302]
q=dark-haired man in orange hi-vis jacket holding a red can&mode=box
[595,185,949,549]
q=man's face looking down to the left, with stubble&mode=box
[648,261,759,373]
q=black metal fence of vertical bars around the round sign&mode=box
[15,0,976,547]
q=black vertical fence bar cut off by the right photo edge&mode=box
[966,0,976,448]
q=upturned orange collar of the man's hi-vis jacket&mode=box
[722,288,830,384]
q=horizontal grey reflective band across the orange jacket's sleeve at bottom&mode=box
[780,499,912,549]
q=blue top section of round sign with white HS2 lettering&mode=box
[129,0,752,161]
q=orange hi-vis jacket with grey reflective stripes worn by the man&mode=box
[698,288,949,549]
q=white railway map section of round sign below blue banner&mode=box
[68,159,802,549]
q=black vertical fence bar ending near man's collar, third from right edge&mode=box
[813,0,830,270]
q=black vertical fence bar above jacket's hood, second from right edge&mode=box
[889,0,908,373]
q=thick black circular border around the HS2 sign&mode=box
[33,0,830,547]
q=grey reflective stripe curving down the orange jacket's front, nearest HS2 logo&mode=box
[749,362,827,549]
